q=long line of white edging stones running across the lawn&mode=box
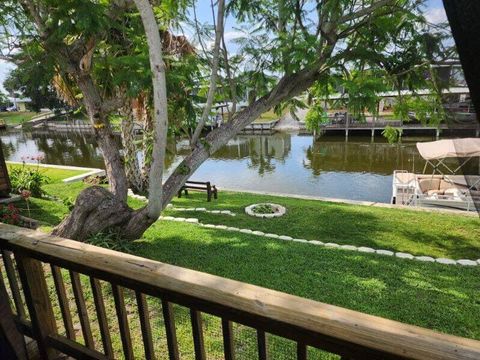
[159,216,480,266]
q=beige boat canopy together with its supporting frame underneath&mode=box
[417,138,480,184]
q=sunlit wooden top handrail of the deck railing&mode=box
[0,224,480,359]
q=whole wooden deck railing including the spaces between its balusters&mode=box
[0,225,480,360]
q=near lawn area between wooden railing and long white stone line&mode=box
[137,224,480,339]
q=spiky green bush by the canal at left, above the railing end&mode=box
[10,163,50,197]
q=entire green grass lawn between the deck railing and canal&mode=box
[3,166,480,359]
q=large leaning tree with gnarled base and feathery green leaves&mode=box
[0,0,438,239]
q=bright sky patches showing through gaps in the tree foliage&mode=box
[0,0,446,92]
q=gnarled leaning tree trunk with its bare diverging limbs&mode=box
[47,0,404,240]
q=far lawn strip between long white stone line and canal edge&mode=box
[165,193,480,259]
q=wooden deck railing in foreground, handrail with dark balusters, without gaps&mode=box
[0,224,480,360]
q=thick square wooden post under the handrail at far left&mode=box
[15,253,57,359]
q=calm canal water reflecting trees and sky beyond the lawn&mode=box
[0,131,464,203]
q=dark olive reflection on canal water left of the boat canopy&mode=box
[303,140,423,176]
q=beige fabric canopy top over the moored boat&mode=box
[417,138,480,160]
